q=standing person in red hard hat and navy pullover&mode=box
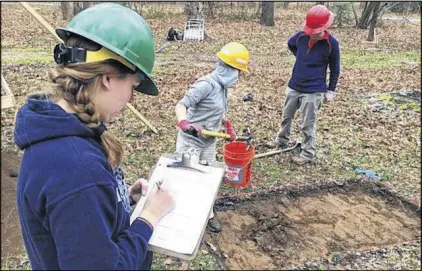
[266,5,340,165]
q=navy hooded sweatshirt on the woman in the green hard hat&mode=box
[15,96,152,270]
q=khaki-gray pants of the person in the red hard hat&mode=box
[275,87,325,160]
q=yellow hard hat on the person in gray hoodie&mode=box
[217,42,249,72]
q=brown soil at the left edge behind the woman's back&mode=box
[1,151,23,258]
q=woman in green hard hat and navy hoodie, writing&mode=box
[14,3,174,270]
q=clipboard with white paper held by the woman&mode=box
[130,154,224,261]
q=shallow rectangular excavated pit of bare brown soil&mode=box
[206,182,420,270]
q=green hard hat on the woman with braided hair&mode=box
[56,3,158,95]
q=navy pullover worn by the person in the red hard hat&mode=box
[287,31,340,93]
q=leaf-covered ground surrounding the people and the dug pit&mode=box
[1,3,421,269]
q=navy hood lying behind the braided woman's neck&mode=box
[14,94,94,150]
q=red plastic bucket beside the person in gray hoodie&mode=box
[223,141,255,187]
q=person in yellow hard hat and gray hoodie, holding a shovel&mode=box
[176,42,249,232]
